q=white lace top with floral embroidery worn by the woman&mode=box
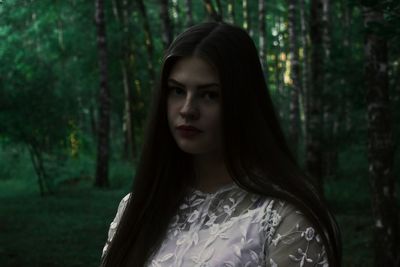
[103,183,329,267]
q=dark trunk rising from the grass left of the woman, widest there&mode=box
[94,0,111,187]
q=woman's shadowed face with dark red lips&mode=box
[167,57,222,155]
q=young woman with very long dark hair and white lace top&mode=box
[102,23,341,267]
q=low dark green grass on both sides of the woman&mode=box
[0,178,372,267]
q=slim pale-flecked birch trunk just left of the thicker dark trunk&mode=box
[288,0,301,161]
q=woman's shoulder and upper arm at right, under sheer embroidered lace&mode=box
[260,197,328,266]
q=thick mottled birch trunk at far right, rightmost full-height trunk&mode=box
[363,1,400,266]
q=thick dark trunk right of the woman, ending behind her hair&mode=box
[306,0,324,193]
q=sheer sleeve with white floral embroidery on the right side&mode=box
[266,202,329,267]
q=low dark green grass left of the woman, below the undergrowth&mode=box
[0,184,124,267]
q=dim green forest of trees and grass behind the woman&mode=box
[0,0,400,267]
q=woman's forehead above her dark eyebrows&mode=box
[168,57,219,84]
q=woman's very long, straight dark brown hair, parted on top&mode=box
[102,22,341,267]
